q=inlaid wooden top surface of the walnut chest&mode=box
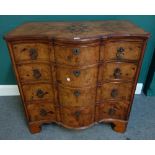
[5,20,149,40]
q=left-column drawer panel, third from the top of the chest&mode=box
[22,84,54,102]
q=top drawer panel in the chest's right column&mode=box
[101,41,143,60]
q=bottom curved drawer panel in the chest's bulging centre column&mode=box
[61,106,95,128]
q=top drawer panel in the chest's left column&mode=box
[13,43,50,62]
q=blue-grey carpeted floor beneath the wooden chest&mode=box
[0,95,155,140]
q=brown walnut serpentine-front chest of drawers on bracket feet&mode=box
[4,21,149,133]
